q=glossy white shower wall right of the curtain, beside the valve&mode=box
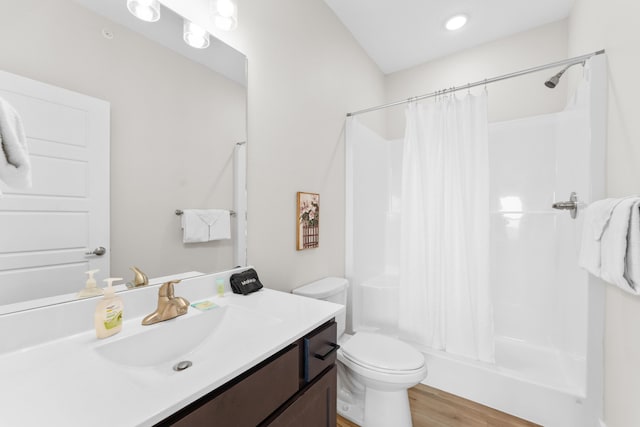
[489,109,589,395]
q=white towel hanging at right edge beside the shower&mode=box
[578,196,640,295]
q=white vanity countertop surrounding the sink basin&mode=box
[0,287,344,427]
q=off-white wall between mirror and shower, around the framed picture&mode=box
[165,0,384,290]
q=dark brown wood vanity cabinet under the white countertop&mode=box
[157,320,337,427]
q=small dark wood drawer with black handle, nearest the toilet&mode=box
[303,321,340,382]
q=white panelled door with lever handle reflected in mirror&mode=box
[0,71,110,305]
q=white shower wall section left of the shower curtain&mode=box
[345,121,402,330]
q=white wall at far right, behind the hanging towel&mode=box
[569,0,640,427]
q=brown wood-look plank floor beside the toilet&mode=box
[337,384,540,427]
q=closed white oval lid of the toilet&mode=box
[342,332,424,371]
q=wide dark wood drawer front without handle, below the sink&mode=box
[171,345,299,427]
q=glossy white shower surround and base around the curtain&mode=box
[346,56,606,427]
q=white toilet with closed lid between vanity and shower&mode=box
[293,277,427,427]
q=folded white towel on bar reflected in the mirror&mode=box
[182,209,231,243]
